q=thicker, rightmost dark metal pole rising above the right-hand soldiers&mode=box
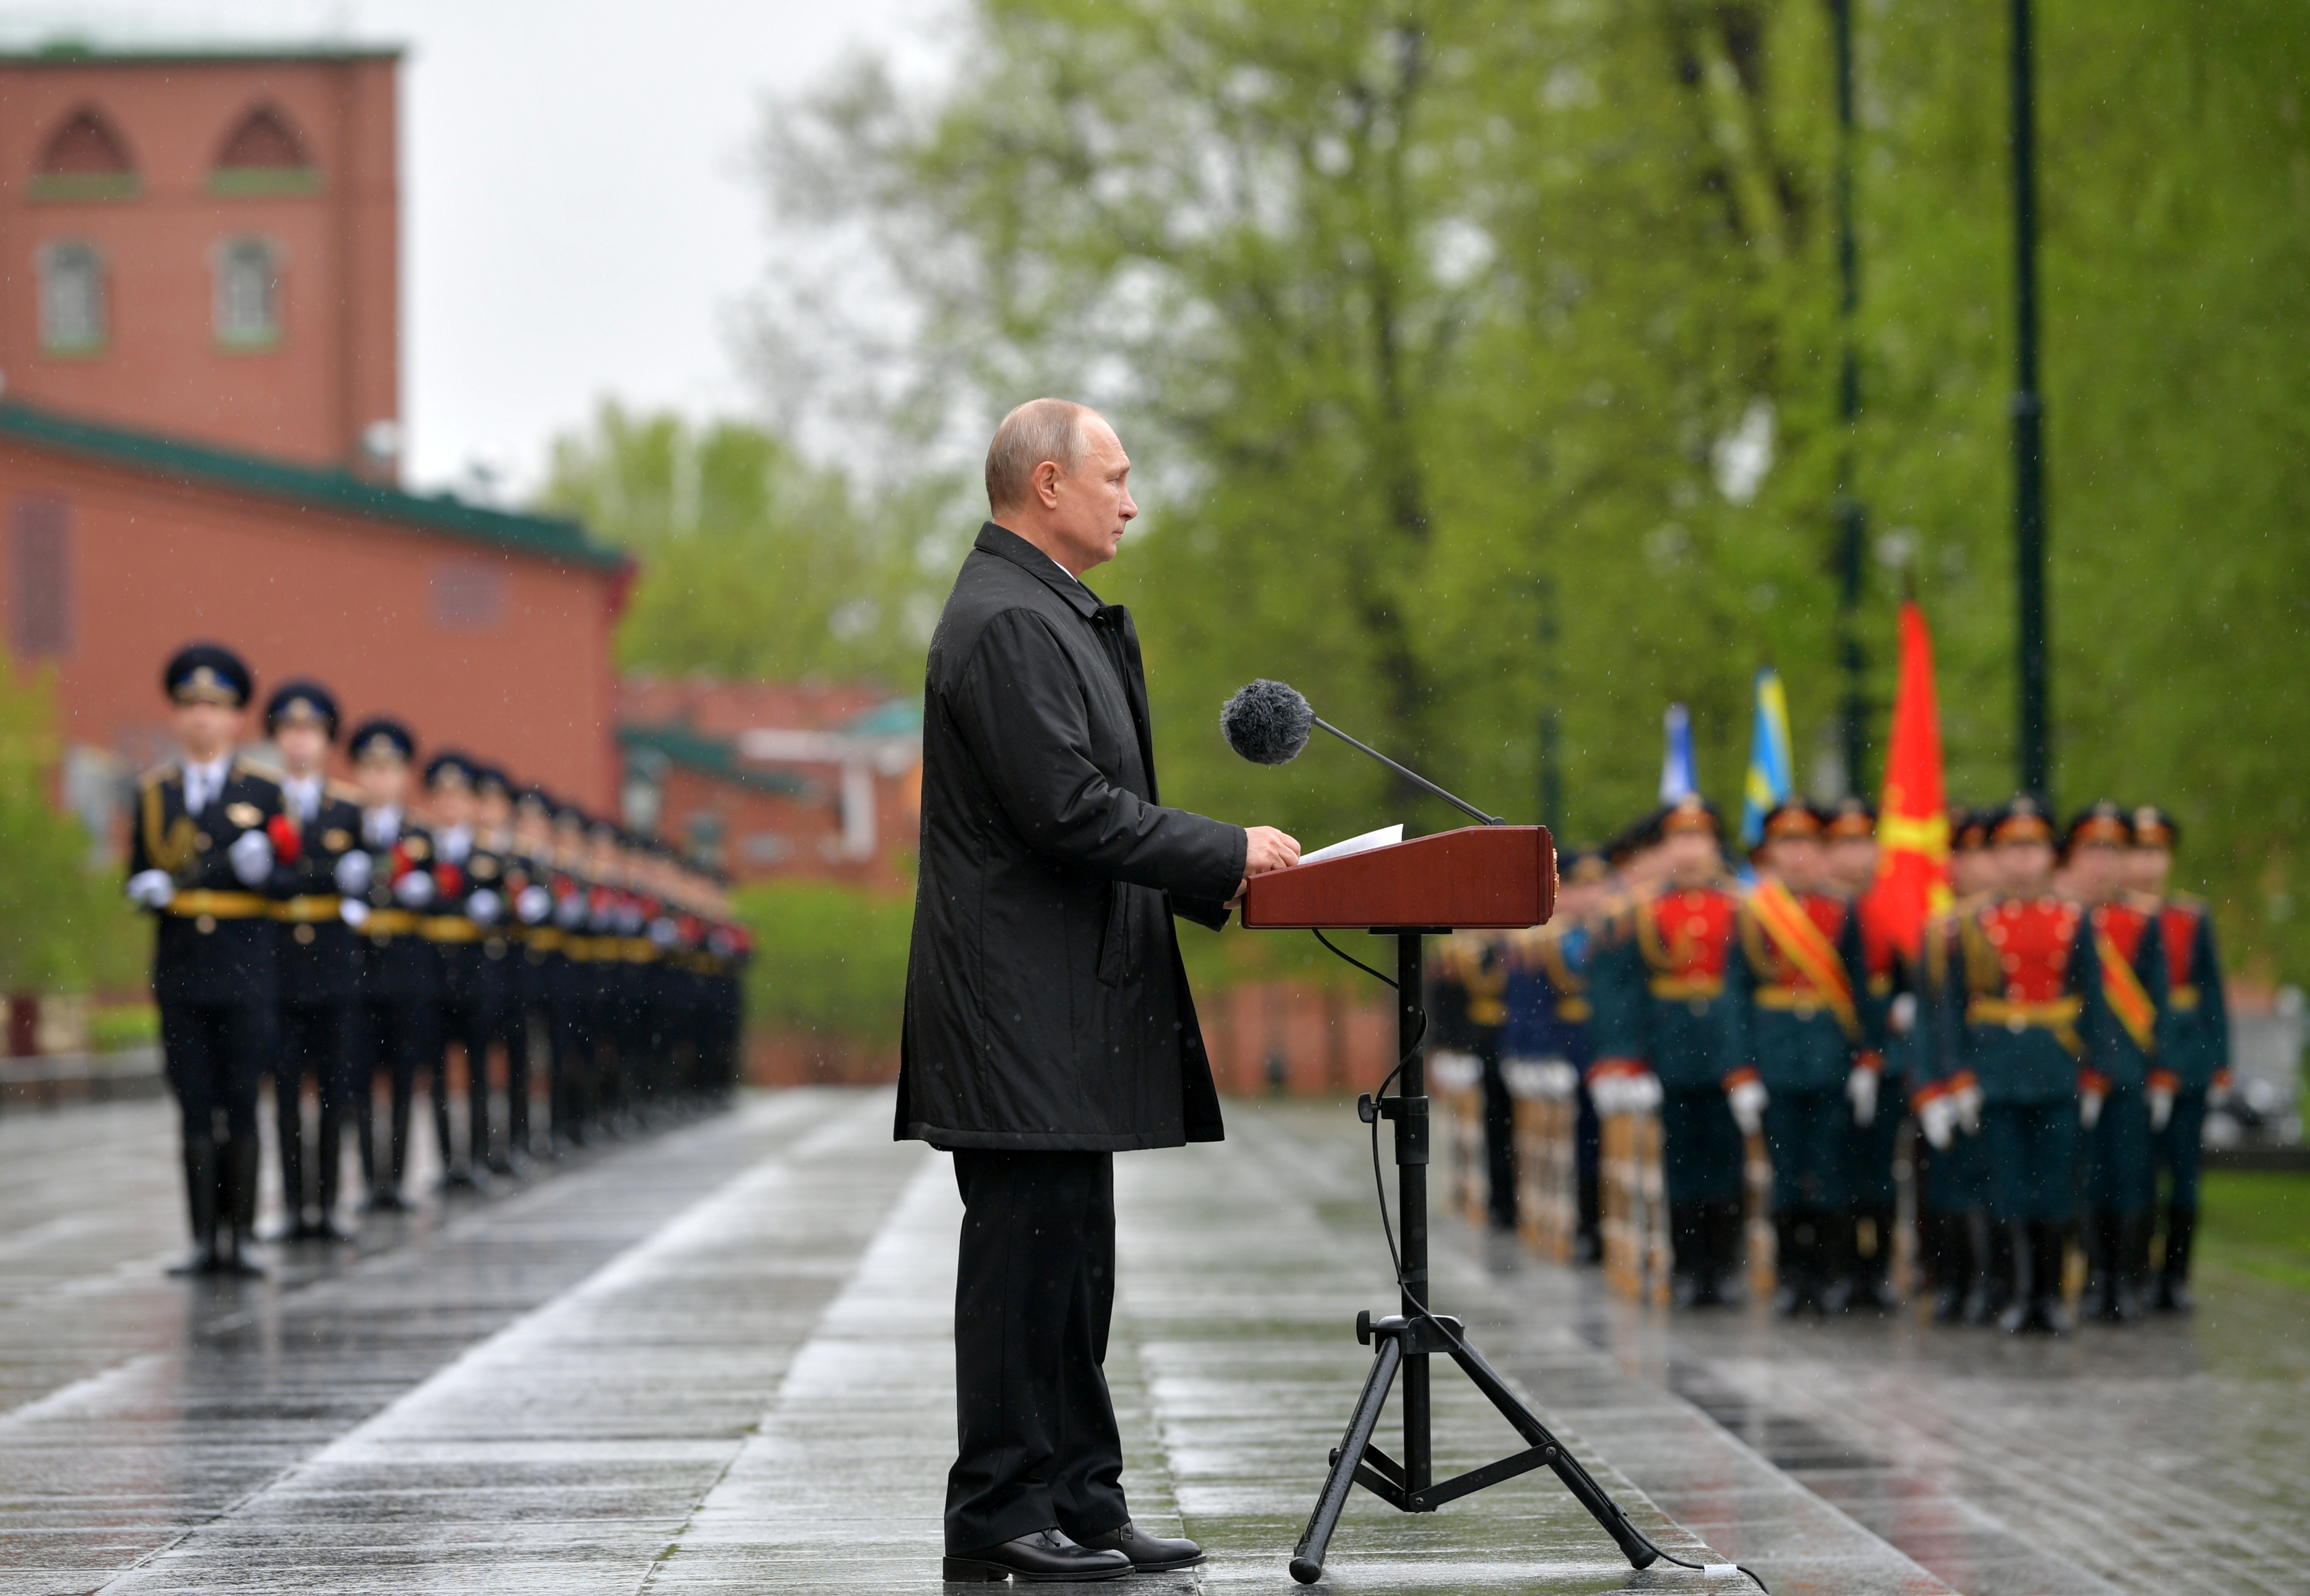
[2012,0,2054,797]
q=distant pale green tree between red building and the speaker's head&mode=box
[543,404,959,688]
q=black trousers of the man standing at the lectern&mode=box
[947,1148,1130,1554]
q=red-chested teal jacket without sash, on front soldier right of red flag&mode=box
[1952,896,2095,1104]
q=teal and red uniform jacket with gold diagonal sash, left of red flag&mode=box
[1726,889,1883,1092]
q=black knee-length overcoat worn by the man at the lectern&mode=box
[899,522,1245,1153]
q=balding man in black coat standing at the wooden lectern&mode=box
[896,400,1298,1580]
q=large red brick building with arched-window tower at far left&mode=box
[0,49,631,818]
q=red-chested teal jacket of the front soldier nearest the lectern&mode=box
[1592,885,1739,1090]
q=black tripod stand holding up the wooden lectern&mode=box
[1291,931,1661,1584]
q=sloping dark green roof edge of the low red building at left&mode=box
[0,402,628,570]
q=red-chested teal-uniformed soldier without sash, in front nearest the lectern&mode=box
[1589,797,1753,1307]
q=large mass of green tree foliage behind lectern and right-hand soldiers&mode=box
[744,0,2310,975]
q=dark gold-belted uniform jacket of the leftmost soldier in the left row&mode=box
[129,758,282,1005]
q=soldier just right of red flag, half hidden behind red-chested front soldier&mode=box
[1906,808,2012,1323]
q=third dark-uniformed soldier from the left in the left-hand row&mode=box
[349,716,441,1213]
